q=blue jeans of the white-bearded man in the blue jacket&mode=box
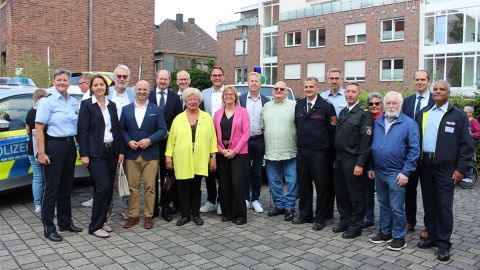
[375,171,407,238]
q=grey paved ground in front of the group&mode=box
[0,180,480,270]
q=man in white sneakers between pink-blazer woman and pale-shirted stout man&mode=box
[239,72,268,213]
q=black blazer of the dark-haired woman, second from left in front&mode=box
[77,98,124,158]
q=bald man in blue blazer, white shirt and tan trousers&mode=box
[120,80,167,229]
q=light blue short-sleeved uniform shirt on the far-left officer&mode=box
[35,90,78,137]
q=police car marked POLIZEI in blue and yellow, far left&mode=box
[0,87,89,192]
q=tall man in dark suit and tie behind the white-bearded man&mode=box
[402,70,435,238]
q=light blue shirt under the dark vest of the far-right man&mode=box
[423,102,448,153]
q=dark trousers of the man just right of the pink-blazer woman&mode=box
[244,136,265,202]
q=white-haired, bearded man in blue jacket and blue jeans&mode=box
[369,91,420,251]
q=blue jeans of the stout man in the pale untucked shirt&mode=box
[265,158,298,209]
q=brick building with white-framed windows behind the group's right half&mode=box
[217,0,420,96]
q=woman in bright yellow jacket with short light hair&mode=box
[165,88,218,226]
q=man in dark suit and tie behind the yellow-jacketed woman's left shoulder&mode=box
[148,69,182,221]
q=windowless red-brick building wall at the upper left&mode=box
[0,0,155,82]
